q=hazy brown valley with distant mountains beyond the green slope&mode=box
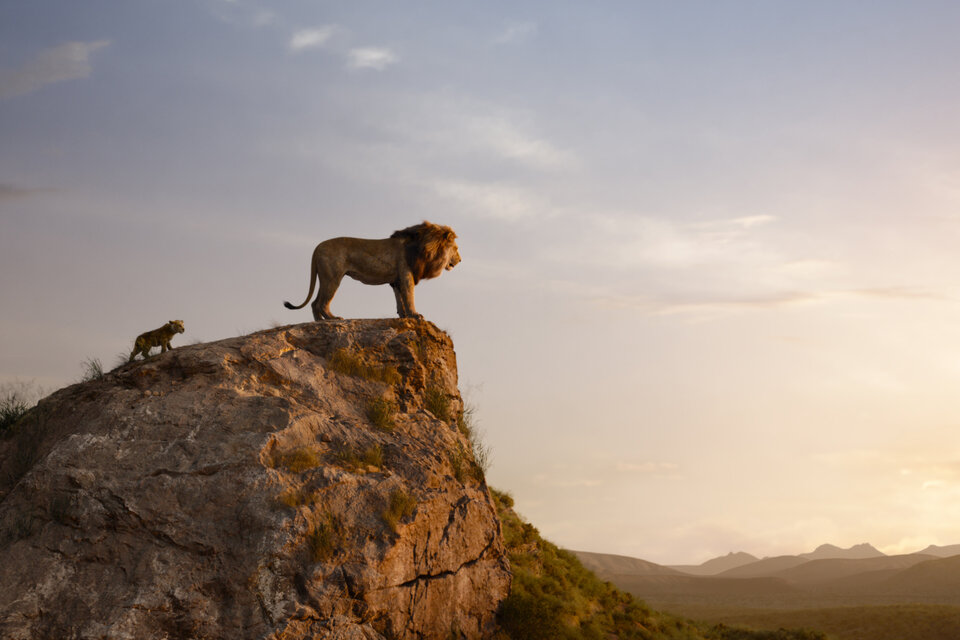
[574,545,960,640]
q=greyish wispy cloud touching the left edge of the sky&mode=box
[0,40,110,100]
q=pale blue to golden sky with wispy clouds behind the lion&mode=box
[0,0,960,563]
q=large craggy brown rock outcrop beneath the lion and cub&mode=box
[0,320,510,640]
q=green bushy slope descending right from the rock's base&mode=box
[491,490,826,640]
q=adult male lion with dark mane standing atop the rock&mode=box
[283,220,460,320]
